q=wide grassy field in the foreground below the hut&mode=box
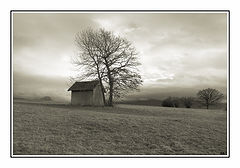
[13,102,227,155]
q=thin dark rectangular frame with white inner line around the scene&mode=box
[10,9,230,158]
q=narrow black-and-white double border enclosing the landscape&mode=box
[10,10,230,158]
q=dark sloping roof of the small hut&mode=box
[68,80,99,91]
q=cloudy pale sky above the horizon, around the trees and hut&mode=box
[12,13,227,100]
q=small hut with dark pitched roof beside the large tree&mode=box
[68,81,104,106]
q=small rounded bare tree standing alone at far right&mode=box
[197,88,224,109]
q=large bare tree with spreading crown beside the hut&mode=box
[74,29,142,106]
